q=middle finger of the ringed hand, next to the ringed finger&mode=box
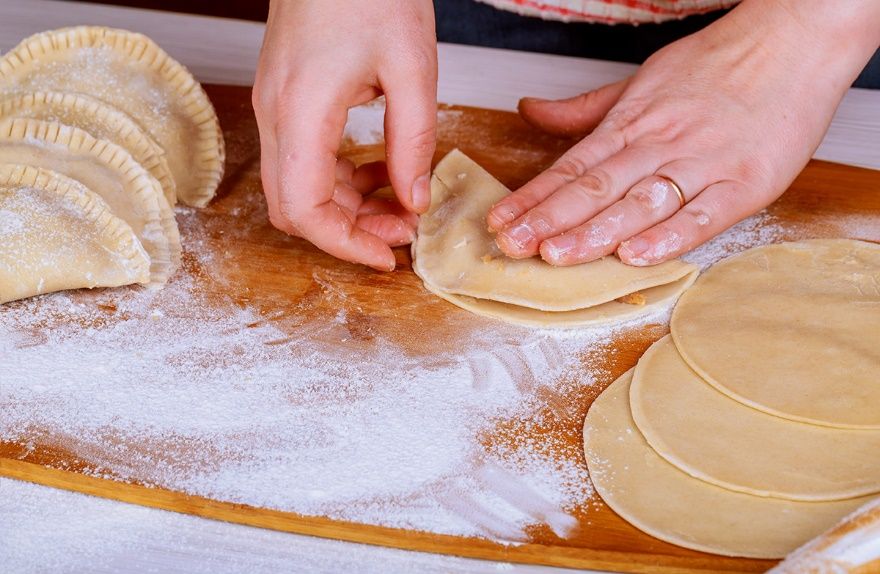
[495,147,660,258]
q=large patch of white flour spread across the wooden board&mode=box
[0,210,611,543]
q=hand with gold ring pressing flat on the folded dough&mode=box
[488,0,880,265]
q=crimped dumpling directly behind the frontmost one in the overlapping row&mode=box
[0,119,181,284]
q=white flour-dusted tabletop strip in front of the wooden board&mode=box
[0,478,576,574]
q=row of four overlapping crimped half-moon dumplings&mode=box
[0,26,225,304]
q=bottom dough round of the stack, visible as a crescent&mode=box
[584,371,872,558]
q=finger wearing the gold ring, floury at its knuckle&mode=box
[540,160,713,265]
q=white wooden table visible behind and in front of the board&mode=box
[0,0,880,574]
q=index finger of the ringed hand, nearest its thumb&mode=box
[486,130,625,231]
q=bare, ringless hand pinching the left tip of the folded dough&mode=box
[253,0,437,271]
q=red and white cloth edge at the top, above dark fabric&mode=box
[477,0,739,24]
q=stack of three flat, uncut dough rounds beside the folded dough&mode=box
[584,239,880,558]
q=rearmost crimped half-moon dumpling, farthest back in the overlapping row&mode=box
[0,26,225,207]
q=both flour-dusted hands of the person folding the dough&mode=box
[254,0,880,270]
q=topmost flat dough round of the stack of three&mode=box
[671,239,880,429]
